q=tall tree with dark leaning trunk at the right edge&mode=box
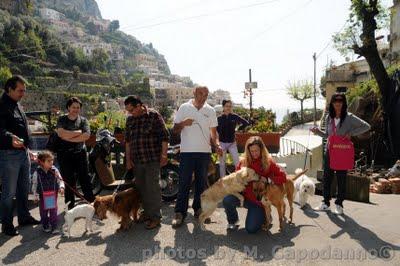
[334,0,400,158]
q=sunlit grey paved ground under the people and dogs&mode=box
[0,194,400,265]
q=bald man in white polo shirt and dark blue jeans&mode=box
[172,87,222,227]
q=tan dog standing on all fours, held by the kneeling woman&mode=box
[253,169,308,231]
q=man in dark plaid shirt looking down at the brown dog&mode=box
[124,96,169,229]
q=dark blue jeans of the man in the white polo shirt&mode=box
[175,152,211,217]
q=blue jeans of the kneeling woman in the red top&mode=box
[222,195,265,234]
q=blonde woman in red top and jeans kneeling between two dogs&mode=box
[223,136,286,233]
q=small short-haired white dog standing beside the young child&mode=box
[63,203,94,237]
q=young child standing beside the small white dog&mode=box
[32,151,64,234]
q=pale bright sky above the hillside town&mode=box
[97,0,391,116]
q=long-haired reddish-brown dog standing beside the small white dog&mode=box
[93,188,141,231]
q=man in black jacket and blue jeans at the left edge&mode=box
[0,76,39,236]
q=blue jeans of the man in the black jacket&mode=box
[0,150,31,226]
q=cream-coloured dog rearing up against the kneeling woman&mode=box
[199,167,259,230]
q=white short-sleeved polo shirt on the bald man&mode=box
[174,100,218,153]
